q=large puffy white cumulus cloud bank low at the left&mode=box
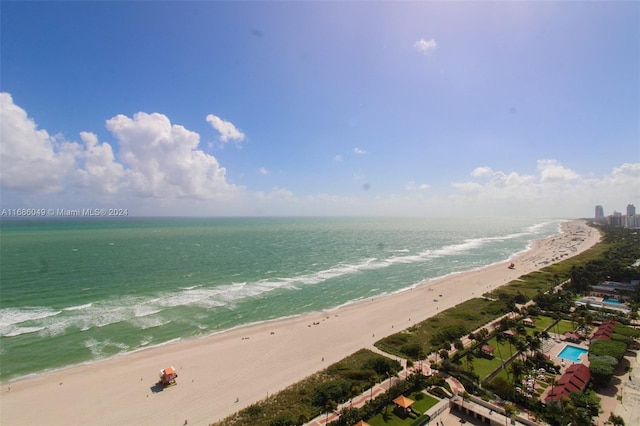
[0,93,244,200]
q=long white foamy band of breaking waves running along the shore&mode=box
[0,221,557,337]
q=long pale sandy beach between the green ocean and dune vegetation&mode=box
[0,221,600,426]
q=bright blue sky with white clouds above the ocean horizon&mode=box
[0,1,640,217]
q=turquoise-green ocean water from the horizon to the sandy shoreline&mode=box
[0,218,560,382]
